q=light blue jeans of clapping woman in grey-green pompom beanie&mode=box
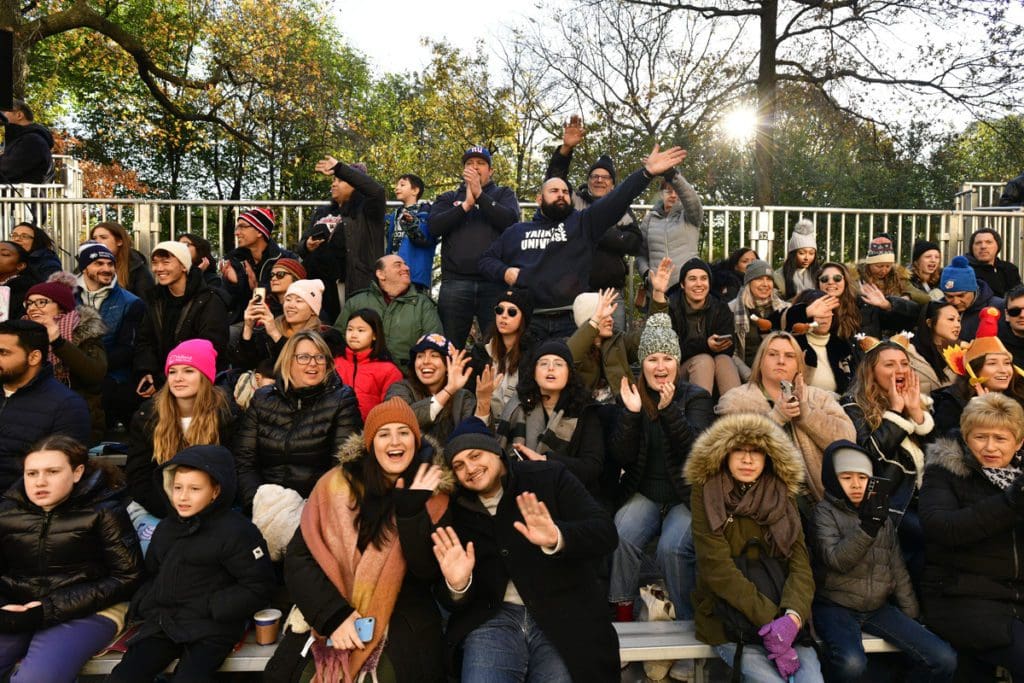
[608,494,696,621]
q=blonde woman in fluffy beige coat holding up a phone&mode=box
[717,332,857,503]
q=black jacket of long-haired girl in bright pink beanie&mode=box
[125,395,236,519]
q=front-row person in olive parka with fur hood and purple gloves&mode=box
[685,414,821,683]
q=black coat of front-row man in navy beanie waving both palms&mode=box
[440,459,621,683]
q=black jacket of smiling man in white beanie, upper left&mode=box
[134,268,227,378]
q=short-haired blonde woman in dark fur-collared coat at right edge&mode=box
[921,391,1024,681]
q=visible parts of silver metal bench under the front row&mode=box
[81,622,898,683]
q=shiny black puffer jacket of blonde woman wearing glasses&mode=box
[234,370,362,510]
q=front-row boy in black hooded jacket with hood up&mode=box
[106,445,274,683]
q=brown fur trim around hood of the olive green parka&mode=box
[684,413,805,496]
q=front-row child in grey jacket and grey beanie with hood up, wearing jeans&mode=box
[812,440,956,681]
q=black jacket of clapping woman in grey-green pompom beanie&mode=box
[608,381,715,506]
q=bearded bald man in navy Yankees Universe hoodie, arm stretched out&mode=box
[479,144,686,341]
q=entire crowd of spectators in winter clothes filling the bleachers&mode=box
[0,124,1024,682]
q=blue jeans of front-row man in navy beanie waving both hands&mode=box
[462,602,572,683]
